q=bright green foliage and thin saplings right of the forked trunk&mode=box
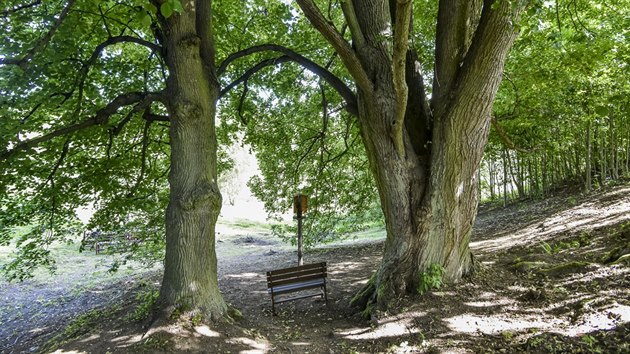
[481,0,630,200]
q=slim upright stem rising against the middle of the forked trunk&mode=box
[392,0,411,157]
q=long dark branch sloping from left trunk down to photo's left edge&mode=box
[0,92,163,161]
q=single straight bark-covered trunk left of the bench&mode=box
[160,1,227,319]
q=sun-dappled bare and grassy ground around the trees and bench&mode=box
[0,185,630,354]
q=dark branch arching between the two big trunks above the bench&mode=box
[217,44,358,115]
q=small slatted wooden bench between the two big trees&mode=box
[267,262,328,315]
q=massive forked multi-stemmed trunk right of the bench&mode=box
[297,0,521,312]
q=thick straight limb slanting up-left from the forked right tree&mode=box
[296,0,374,96]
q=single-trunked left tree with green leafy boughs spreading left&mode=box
[0,0,237,318]
